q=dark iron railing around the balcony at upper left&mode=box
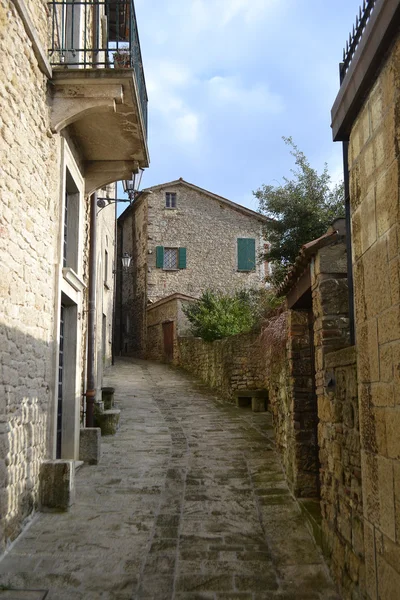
[48,0,148,134]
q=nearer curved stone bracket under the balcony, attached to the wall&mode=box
[51,81,124,133]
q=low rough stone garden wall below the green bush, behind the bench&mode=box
[177,333,265,402]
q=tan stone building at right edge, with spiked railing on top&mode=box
[332,0,400,600]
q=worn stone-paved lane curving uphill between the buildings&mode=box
[0,360,339,600]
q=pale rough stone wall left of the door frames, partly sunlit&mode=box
[0,0,60,550]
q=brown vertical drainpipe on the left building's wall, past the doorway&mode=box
[86,192,97,427]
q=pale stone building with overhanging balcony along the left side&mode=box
[0,0,148,549]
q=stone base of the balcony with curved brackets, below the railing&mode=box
[49,68,149,194]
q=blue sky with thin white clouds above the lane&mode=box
[121,0,360,210]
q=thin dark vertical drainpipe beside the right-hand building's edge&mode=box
[339,63,356,346]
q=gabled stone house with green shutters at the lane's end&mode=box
[116,179,267,356]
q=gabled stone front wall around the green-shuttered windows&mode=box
[148,184,264,301]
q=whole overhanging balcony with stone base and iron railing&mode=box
[48,0,149,193]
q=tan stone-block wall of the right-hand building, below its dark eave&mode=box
[349,35,400,600]
